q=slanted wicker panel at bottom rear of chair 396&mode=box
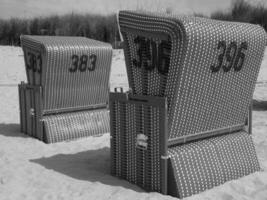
[168,131,260,198]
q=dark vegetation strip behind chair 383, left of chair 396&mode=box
[0,13,119,46]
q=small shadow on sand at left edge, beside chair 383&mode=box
[0,124,28,138]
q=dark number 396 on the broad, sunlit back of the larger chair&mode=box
[210,41,248,72]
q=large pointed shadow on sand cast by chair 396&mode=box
[30,147,143,192]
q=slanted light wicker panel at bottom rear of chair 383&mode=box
[42,109,110,143]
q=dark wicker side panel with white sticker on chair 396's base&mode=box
[110,93,167,193]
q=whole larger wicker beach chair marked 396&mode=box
[110,11,267,198]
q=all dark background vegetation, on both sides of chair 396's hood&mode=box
[0,0,267,46]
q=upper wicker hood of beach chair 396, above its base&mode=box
[119,11,266,138]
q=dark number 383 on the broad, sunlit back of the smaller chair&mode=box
[69,54,97,72]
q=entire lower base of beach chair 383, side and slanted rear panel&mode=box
[18,82,109,143]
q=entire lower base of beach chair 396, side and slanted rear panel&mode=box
[110,92,260,198]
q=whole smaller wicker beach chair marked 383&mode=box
[19,35,112,143]
